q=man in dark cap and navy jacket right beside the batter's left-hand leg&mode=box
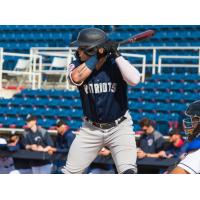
[53,119,74,173]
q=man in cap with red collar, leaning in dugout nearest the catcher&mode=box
[167,128,188,158]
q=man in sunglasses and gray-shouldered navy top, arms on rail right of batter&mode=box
[137,118,167,159]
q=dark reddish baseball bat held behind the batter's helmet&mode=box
[119,30,155,46]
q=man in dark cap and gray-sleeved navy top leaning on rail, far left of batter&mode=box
[23,115,53,174]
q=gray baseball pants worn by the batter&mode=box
[62,112,137,174]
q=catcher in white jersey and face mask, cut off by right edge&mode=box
[171,100,200,174]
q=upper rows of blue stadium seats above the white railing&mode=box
[0,25,200,52]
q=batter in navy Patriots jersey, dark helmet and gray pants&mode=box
[62,28,140,174]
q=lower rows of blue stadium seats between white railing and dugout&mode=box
[0,71,200,134]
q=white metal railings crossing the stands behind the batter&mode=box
[0,47,200,89]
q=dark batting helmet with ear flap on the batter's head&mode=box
[71,28,108,55]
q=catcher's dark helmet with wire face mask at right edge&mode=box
[183,100,200,141]
